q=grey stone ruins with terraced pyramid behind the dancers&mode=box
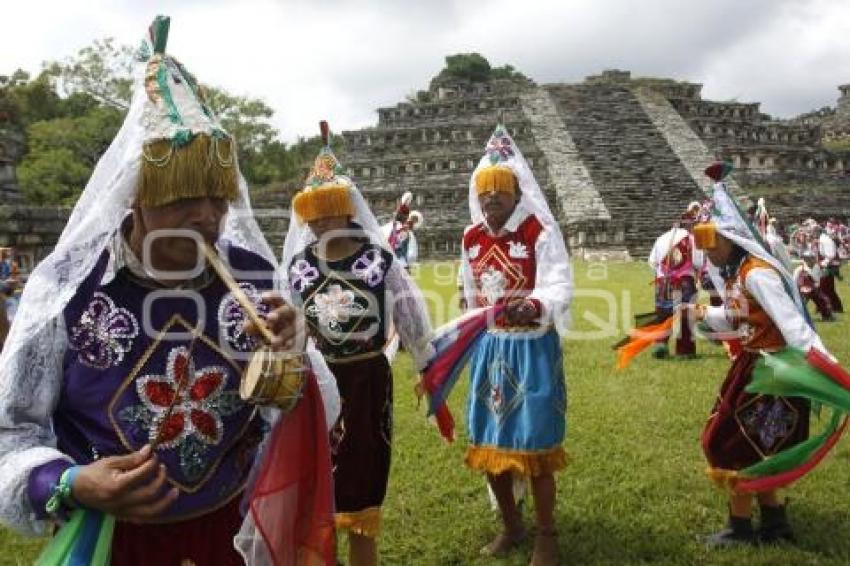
[0,71,850,272]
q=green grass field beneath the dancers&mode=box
[0,262,850,565]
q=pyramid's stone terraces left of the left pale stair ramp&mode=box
[343,81,554,258]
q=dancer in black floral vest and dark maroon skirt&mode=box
[283,122,432,566]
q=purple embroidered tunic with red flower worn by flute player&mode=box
[28,247,273,521]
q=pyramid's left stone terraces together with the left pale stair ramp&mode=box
[343,77,625,258]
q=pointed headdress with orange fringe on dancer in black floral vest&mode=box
[292,120,354,222]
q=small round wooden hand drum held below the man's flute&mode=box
[239,346,307,414]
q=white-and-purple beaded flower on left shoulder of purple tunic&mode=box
[70,291,139,369]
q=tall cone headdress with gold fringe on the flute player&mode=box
[136,16,239,207]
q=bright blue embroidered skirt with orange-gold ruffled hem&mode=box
[466,330,567,476]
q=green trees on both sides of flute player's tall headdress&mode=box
[7,38,322,204]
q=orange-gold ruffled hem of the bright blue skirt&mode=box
[465,446,568,477]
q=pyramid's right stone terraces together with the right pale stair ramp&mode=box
[587,71,850,246]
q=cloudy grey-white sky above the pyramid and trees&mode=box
[0,0,850,141]
